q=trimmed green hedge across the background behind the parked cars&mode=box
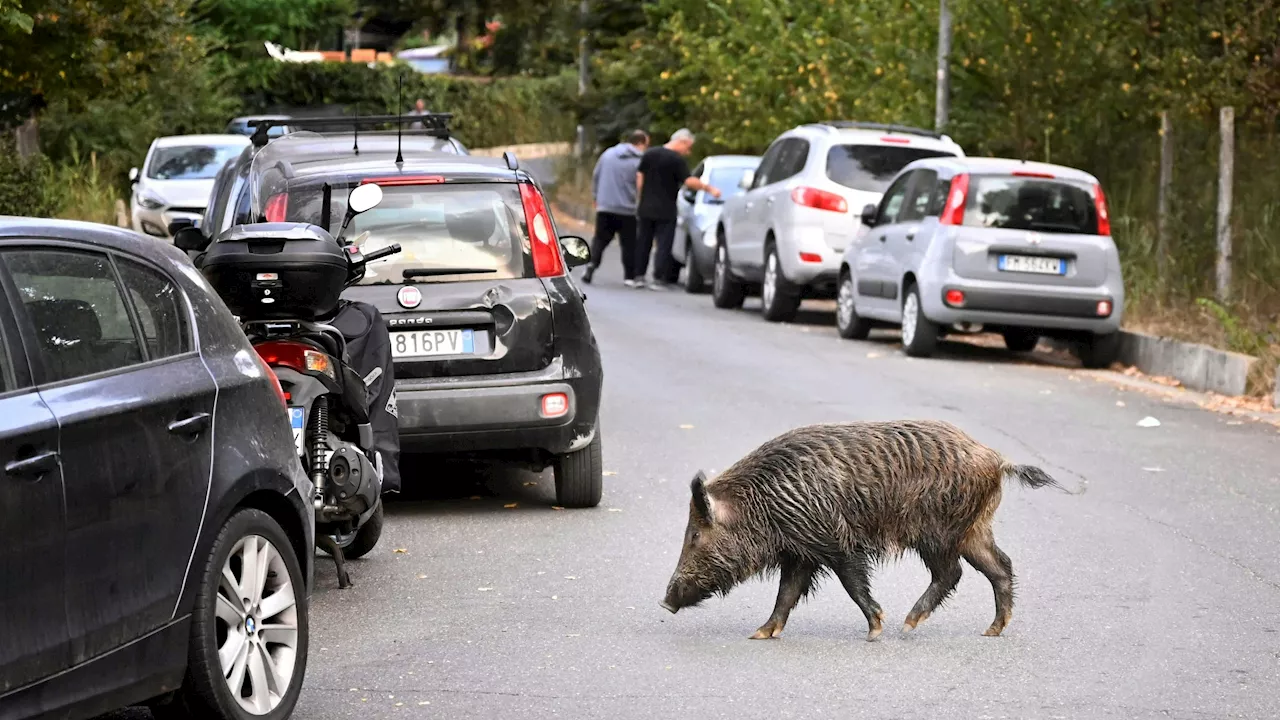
[239,61,576,147]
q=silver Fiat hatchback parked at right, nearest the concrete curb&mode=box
[836,158,1124,368]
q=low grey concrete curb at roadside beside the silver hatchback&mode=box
[1050,331,1254,394]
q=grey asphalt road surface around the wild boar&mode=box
[288,246,1280,720]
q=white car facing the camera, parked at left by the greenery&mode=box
[129,135,250,240]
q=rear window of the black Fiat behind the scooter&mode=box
[287,182,532,284]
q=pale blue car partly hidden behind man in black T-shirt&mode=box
[671,155,760,292]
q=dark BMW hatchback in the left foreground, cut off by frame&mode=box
[0,218,315,720]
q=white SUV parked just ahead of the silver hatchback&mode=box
[713,122,964,322]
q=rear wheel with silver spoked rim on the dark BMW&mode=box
[152,509,308,720]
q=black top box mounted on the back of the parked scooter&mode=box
[201,223,349,320]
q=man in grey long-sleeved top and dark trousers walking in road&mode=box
[582,129,649,287]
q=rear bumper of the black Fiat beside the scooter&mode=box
[396,359,599,455]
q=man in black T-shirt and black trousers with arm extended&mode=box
[634,128,719,290]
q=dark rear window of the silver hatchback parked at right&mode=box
[964,176,1098,234]
